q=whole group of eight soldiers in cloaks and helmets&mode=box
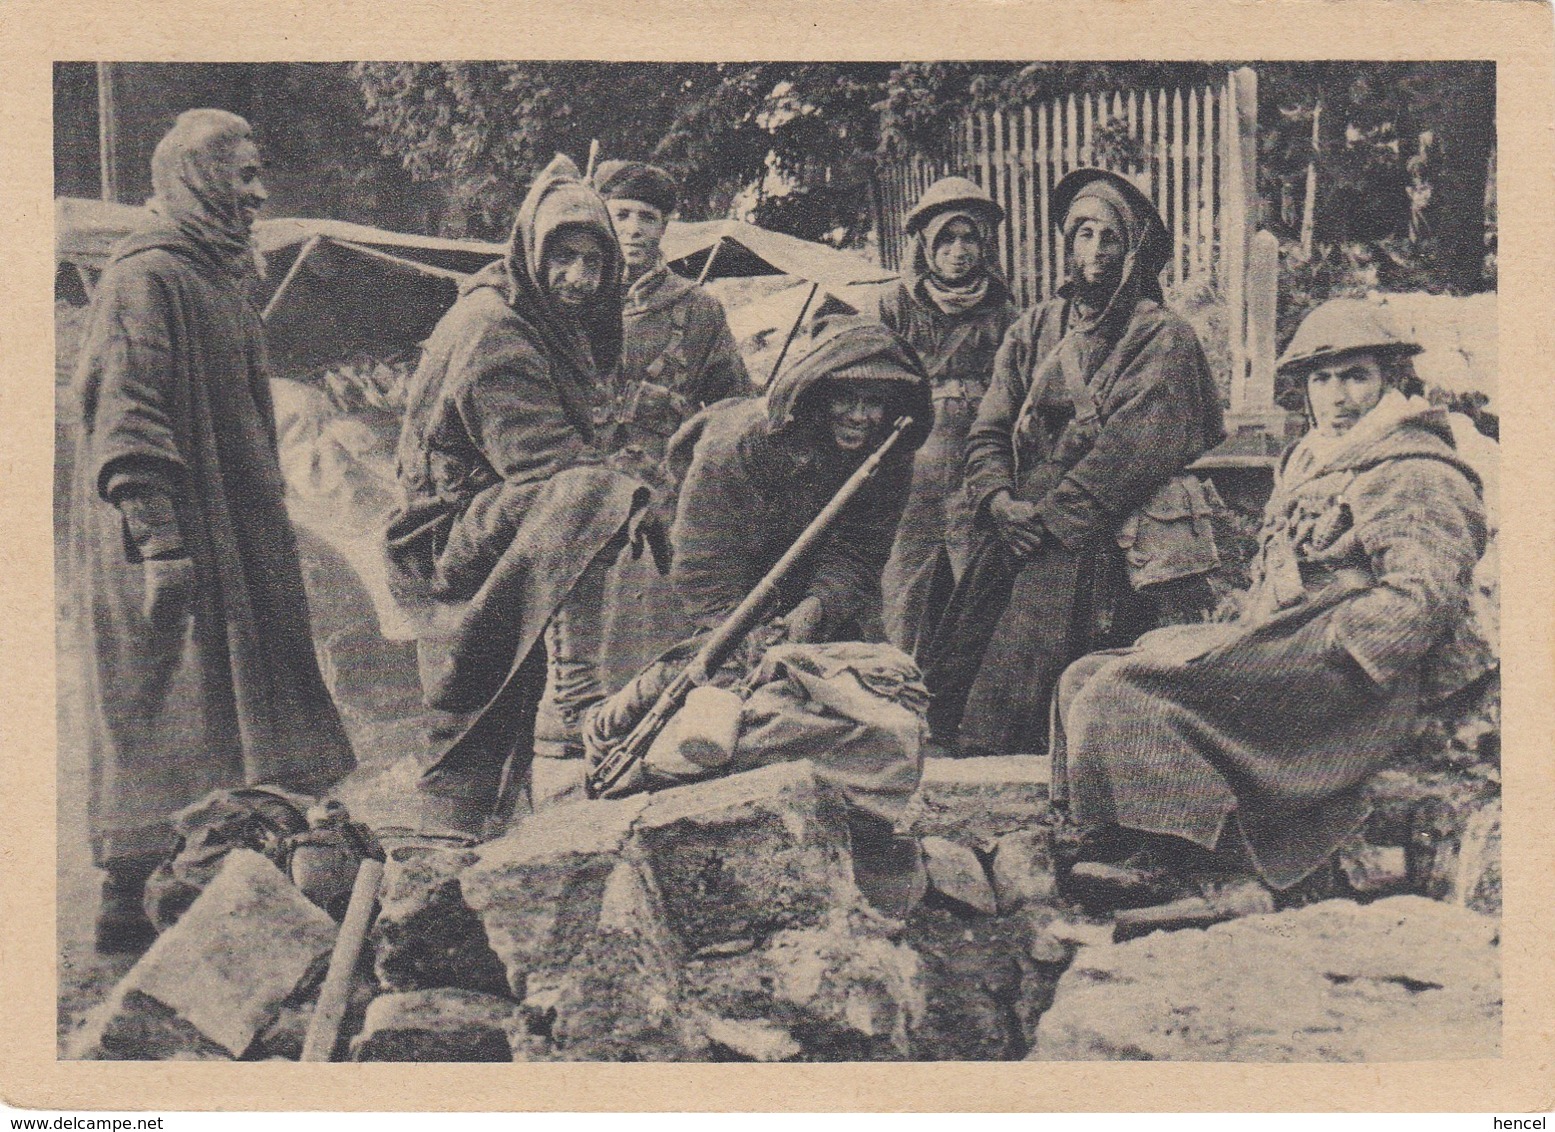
[72,110,1485,950]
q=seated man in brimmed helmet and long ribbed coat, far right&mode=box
[1054,300,1485,907]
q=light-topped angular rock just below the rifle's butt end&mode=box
[459,795,647,1000]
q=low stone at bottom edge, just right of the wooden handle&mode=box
[351,987,524,1062]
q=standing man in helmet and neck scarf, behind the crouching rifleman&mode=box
[880,177,1015,653]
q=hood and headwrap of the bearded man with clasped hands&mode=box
[1053,169,1171,322]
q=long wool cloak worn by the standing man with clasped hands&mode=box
[917,295,1222,754]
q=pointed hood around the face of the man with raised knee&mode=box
[505,154,622,373]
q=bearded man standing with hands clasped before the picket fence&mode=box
[917,169,1224,754]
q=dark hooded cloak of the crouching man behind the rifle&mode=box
[669,319,931,639]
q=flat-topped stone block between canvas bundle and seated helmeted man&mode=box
[902,754,1053,851]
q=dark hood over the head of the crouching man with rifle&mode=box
[767,316,935,452]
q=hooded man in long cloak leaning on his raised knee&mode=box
[389,157,652,833]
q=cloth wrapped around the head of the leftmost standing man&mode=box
[146,110,253,274]
